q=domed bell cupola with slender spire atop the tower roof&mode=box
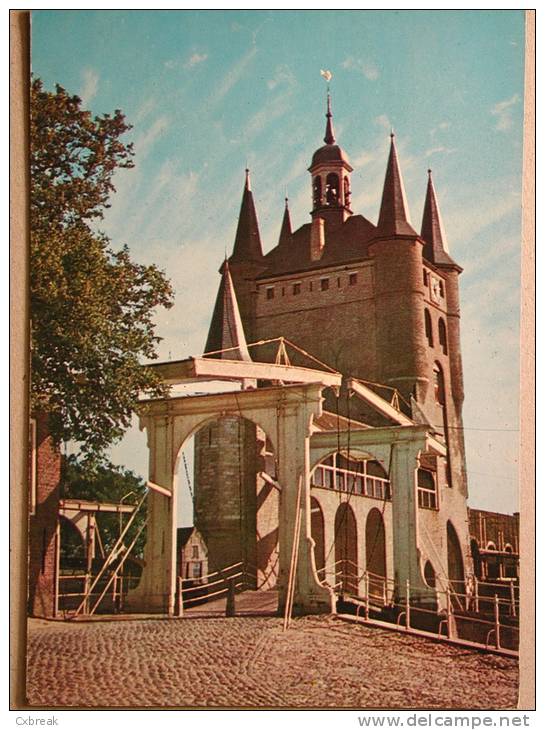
[308,92,353,221]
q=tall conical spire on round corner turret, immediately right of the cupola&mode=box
[377,131,418,236]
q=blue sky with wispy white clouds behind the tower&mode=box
[32,10,524,511]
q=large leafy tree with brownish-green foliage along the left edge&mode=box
[30,79,172,460]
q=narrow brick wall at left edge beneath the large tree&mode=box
[28,415,61,617]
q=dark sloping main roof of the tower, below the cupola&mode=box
[258,215,375,279]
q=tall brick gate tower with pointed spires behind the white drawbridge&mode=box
[195,94,469,582]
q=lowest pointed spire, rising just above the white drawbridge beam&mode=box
[205,259,251,361]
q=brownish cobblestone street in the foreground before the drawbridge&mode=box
[27,616,517,709]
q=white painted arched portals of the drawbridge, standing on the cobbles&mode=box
[127,376,445,615]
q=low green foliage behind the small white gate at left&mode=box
[61,454,146,557]
